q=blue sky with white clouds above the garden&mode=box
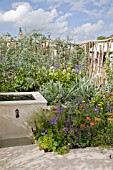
[0,0,113,42]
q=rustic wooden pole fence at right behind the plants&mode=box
[80,38,113,85]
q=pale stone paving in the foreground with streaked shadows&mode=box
[0,144,113,170]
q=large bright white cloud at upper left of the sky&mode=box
[0,3,71,34]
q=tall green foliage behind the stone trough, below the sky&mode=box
[0,30,85,93]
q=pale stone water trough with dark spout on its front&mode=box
[0,92,47,147]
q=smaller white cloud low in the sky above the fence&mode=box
[71,20,104,41]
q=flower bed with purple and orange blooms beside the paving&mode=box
[29,94,113,154]
